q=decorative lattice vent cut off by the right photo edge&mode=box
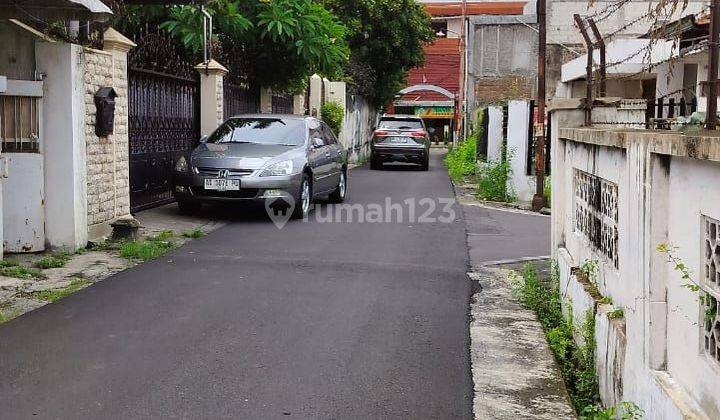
[700,216,720,362]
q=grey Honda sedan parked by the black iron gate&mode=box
[173,114,347,218]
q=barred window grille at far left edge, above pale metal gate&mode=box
[0,96,40,153]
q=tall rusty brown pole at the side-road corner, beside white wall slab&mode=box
[530,0,548,211]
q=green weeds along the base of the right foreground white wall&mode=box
[513,264,600,413]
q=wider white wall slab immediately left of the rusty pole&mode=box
[507,101,535,202]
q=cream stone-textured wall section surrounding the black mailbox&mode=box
[84,49,130,230]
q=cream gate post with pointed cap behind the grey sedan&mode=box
[195,60,228,136]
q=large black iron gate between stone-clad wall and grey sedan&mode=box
[128,68,200,212]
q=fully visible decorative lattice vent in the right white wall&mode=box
[575,169,618,268]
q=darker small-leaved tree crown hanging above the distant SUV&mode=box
[323,0,435,105]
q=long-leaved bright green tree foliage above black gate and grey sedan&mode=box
[115,0,350,91]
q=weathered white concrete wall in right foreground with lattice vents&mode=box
[552,109,720,419]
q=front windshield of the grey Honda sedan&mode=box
[207,118,305,146]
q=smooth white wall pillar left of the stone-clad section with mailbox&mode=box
[35,42,87,249]
